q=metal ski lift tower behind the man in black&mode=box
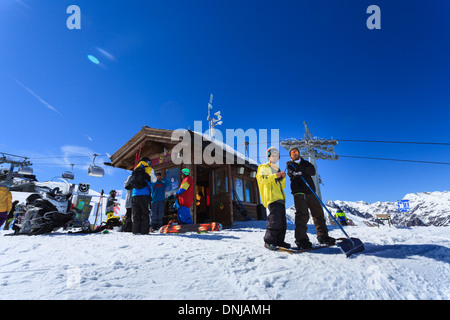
[280,121,339,200]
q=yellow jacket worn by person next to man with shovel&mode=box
[256,162,286,208]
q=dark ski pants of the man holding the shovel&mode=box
[294,193,328,240]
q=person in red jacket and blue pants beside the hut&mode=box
[176,168,194,224]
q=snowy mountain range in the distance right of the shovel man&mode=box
[320,191,450,227]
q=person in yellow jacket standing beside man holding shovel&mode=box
[256,147,290,250]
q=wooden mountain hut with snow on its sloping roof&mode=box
[109,126,266,227]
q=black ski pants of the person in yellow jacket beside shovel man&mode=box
[264,201,287,246]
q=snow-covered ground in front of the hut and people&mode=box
[0,221,450,300]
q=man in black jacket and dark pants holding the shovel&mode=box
[286,147,336,249]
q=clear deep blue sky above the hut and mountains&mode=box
[0,0,450,208]
